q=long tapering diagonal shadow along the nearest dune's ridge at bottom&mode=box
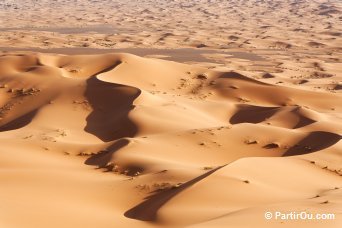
[124,166,224,221]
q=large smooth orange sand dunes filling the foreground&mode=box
[0,53,342,228]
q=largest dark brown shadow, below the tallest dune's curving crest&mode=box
[84,61,141,142]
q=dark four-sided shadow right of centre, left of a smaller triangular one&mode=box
[229,105,279,124]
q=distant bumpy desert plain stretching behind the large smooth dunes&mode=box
[0,0,342,93]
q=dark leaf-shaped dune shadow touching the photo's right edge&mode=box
[283,131,342,157]
